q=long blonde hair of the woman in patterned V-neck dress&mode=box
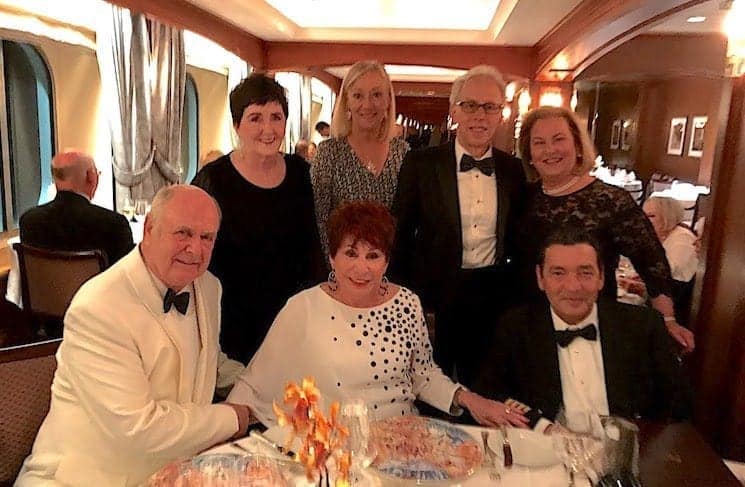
[331,61,396,140]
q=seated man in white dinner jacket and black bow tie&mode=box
[16,186,249,487]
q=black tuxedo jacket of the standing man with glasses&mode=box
[389,142,525,308]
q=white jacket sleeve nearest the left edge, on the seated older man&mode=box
[59,293,238,459]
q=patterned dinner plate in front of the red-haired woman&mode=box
[371,416,484,485]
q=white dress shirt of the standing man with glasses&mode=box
[455,139,497,269]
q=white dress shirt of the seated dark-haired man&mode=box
[551,305,609,417]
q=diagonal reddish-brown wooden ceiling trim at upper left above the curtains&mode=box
[107,0,266,69]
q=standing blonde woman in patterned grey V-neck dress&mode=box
[311,61,408,255]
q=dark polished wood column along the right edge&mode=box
[692,76,745,461]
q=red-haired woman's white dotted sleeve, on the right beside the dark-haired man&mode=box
[410,297,462,415]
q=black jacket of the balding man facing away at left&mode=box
[19,191,134,265]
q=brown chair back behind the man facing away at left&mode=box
[13,242,108,333]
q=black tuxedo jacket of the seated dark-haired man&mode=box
[474,299,690,420]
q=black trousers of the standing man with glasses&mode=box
[434,266,514,387]
